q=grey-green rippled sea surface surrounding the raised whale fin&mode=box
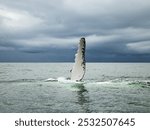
[0,63,150,113]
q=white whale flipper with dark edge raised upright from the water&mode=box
[70,38,86,81]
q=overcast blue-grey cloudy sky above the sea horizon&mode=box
[0,0,150,62]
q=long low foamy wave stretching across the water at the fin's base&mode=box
[0,77,150,88]
